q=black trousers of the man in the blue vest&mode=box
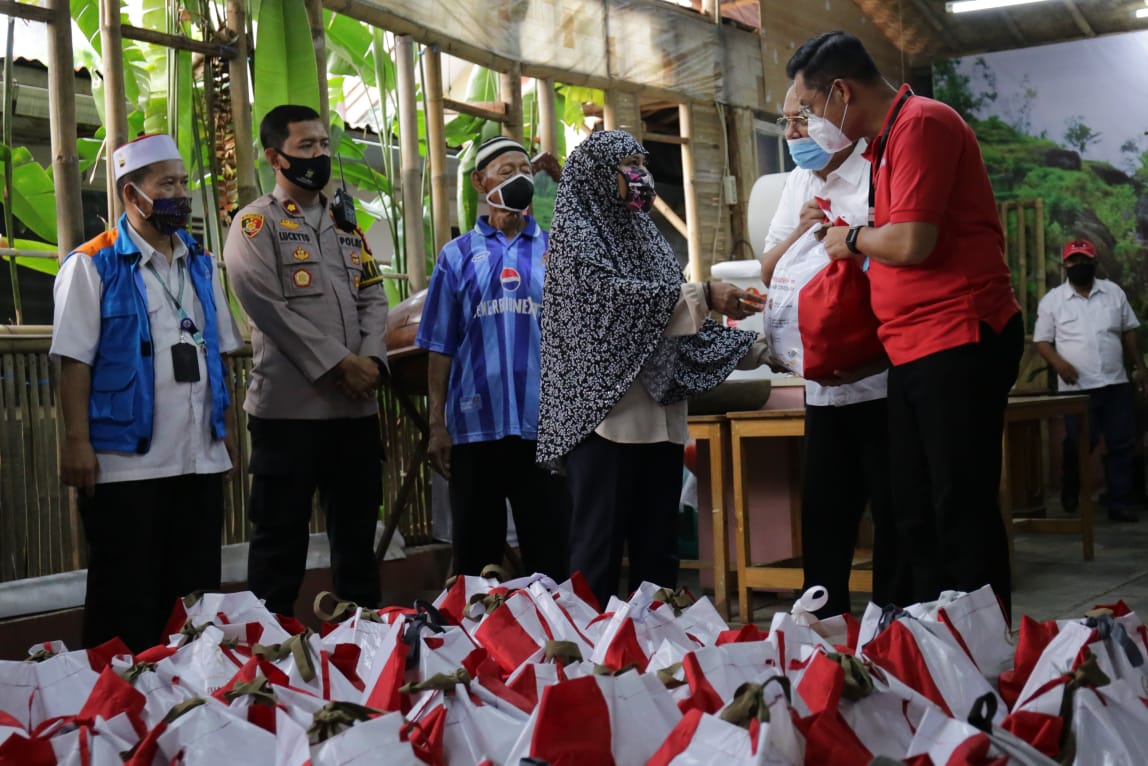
[78,473,223,652]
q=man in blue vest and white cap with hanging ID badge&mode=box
[51,134,242,652]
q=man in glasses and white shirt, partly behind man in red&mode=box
[761,87,897,617]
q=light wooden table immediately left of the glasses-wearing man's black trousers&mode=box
[726,408,872,622]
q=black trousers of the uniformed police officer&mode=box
[247,416,382,614]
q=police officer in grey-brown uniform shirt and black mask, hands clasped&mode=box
[224,105,387,614]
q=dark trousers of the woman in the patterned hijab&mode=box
[566,434,683,609]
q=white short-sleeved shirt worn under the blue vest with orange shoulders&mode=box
[49,227,242,483]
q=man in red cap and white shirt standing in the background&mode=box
[1032,239,1148,521]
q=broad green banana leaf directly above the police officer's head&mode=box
[251,0,319,125]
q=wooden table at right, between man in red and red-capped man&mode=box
[1000,395,1094,562]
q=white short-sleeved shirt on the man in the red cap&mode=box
[1032,278,1140,390]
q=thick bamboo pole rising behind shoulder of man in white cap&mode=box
[48,0,84,258]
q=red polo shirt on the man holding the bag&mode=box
[864,85,1021,364]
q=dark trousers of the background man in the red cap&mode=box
[1061,382,1137,511]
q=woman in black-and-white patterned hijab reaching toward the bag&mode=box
[538,131,766,606]
